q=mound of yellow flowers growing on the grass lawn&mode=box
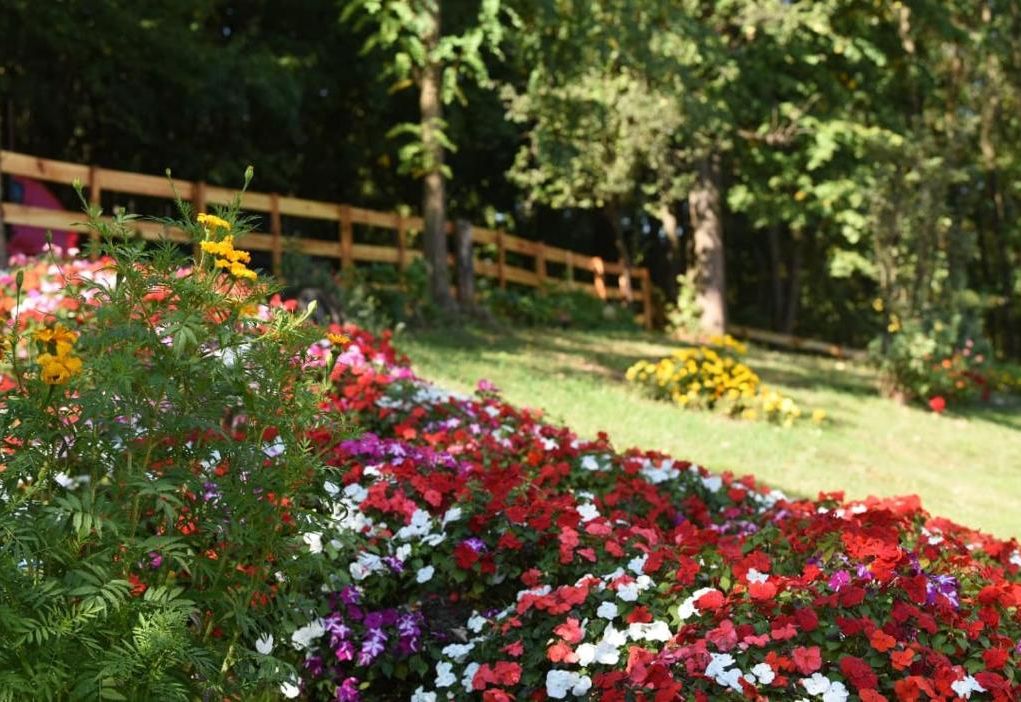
[626,335,826,427]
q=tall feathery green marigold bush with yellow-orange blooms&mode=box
[0,184,341,700]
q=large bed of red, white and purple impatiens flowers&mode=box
[0,249,1021,702]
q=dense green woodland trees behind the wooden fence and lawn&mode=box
[0,0,1021,357]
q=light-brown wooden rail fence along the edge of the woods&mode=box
[0,151,652,328]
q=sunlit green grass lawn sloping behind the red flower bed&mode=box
[397,330,1021,537]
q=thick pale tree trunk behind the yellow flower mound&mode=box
[688,156,727,334]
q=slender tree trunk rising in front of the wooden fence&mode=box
[419,0,456,310]
